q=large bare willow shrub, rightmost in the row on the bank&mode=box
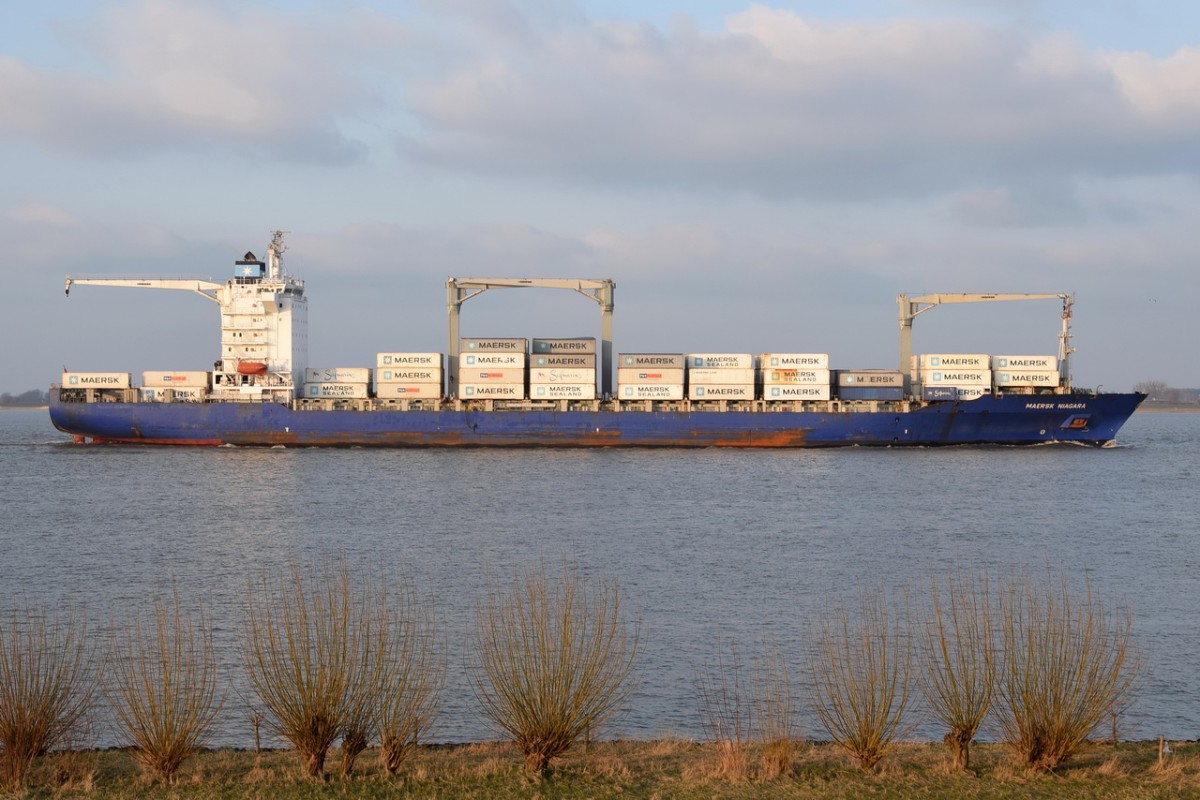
[997,576,1142,771]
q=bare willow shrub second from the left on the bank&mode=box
[107,593,222,782]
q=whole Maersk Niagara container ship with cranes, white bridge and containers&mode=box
[49,231,1145,447]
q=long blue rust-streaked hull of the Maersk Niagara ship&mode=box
[50,392,1145,447]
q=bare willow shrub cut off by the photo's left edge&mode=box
[0,602,97,787]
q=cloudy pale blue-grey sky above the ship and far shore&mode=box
[0,0,1200,393]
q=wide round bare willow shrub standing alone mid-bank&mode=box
[472,565,637,775]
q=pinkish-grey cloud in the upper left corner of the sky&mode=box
[0,0,403,162]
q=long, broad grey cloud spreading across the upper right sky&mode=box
[400,6,1200,199]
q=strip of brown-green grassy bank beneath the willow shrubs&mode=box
[16,740,1200,800]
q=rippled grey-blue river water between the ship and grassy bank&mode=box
[0,410,1200,746]
